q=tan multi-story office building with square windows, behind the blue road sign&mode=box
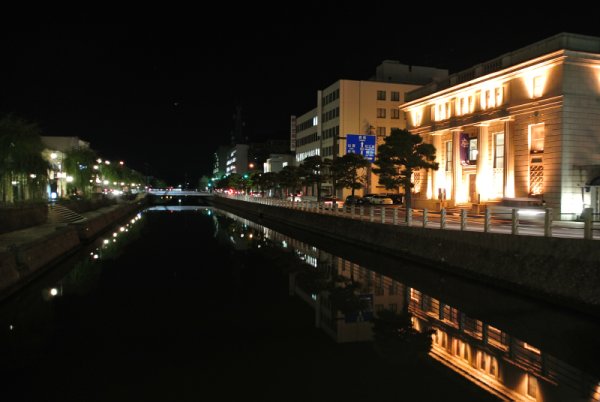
[292,60,448,197]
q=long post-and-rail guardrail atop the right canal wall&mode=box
[227,195,600,240]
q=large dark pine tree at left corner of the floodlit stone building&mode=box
[373,128,439,208]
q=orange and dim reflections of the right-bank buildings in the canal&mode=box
[213,211,600,401]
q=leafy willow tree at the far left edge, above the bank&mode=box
[0,115,49,202]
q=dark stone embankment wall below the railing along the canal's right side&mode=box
[212,197,600,316]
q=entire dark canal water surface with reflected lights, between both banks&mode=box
[0,206,600,401]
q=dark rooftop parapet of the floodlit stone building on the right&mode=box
[406,32,600,102]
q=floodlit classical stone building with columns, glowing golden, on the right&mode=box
[401,33,600,220]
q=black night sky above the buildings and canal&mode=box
[0,7,600,185]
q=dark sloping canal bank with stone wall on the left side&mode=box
[0,200,145,300]
